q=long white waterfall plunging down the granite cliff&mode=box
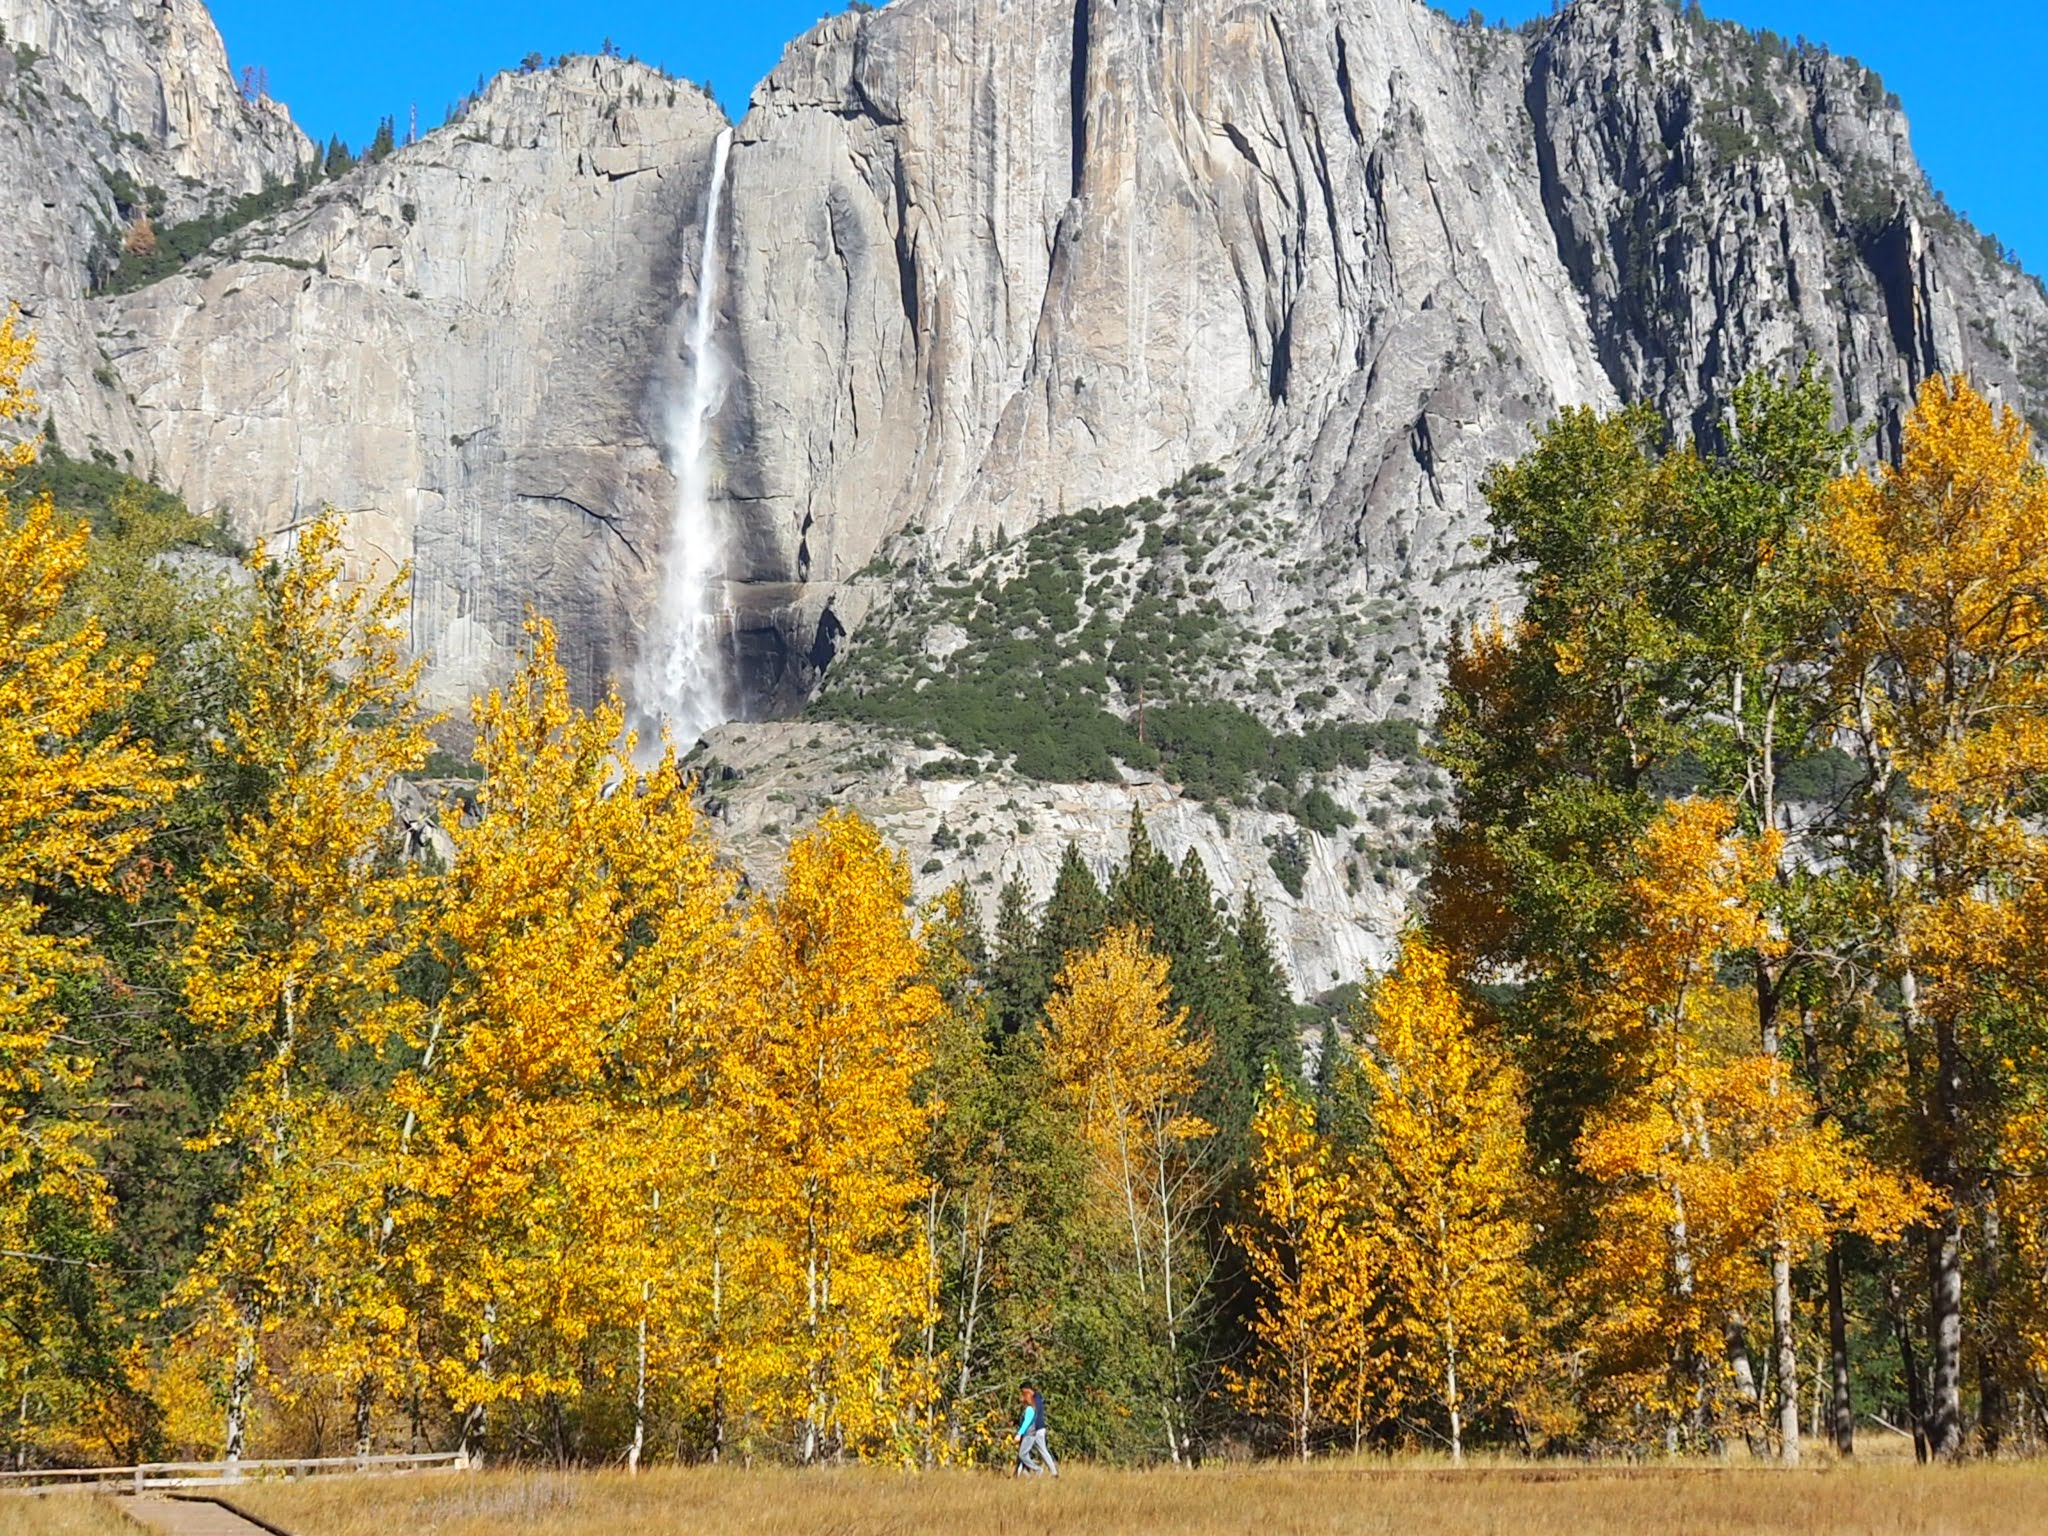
[637,129,737,752]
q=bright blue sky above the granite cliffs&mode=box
[211,0,2048,274]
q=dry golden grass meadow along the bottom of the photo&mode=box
[16,1462,2048,1536]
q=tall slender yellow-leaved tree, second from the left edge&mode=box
[184,512,428,1462]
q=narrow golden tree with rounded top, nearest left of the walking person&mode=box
[748,813,940,1462]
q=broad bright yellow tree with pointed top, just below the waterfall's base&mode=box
[419,621,735,1456]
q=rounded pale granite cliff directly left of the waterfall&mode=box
[102,59,725,712]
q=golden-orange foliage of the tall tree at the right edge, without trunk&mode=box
[1825,377,2048,1016]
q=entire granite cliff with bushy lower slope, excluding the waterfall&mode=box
[0,0,2048,991]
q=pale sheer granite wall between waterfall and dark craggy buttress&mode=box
[725,0,1612,692]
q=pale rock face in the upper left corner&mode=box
[0,0,313,467]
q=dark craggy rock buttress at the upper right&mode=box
[1528,0,2048,446]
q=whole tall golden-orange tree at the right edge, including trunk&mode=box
[1821,377,2048,1458]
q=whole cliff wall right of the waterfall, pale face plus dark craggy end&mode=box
[723,0,2048,684]
